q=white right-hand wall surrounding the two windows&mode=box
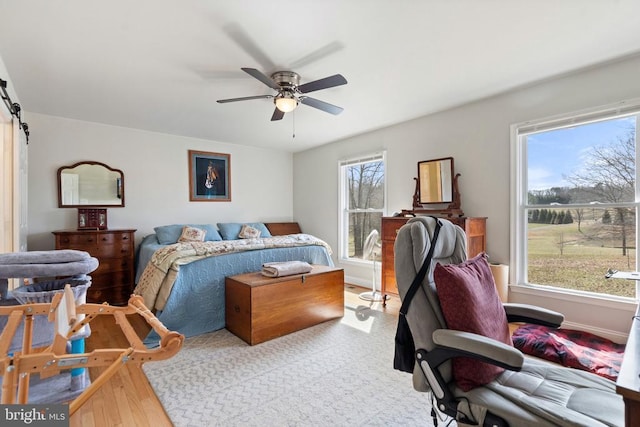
[293,56,640,342]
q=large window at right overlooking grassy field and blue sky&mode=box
[514,102,640,298]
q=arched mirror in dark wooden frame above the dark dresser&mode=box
[58,161,124,208]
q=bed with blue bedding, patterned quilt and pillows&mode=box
[134,223,333,346]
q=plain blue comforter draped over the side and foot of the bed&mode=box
[136,234,333,346]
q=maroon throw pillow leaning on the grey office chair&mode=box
[433,254,513,391]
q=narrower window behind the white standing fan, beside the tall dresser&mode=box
[339,153,386,261]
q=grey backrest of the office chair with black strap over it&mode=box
[394,217,467,391]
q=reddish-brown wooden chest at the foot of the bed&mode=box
[225,265,344,345]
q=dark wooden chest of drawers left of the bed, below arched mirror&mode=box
[53,230,136,305]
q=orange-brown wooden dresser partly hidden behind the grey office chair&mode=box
[381,217,487,296]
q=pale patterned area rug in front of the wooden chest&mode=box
[144,306,438,427]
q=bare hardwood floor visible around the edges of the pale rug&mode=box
[70,284,400,427]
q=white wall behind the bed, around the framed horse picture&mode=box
[28,113,293,250]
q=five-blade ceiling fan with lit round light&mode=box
[218,68,347,121]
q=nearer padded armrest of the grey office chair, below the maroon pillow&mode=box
[432,329,524,371]
